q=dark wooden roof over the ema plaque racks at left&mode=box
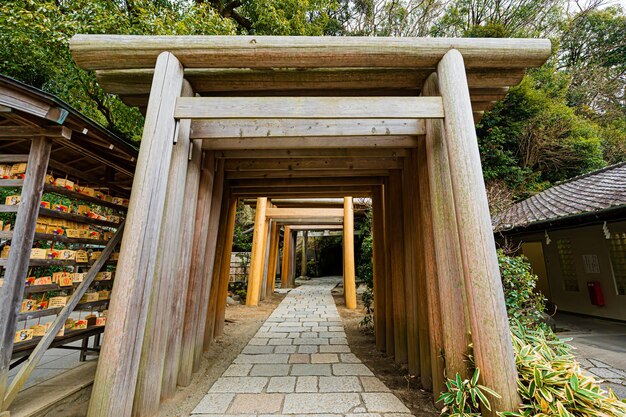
[0,74,138,196]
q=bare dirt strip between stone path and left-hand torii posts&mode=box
[158,294,284,417]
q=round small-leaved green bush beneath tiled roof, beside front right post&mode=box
[498,250,546,328]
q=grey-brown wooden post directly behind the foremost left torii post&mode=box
[133,82,193,417]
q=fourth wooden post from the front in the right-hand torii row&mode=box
[397,157,422,376]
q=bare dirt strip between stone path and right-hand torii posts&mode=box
[334,294,439,417]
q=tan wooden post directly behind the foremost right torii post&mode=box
[420,73,471,384]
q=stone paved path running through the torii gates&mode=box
[192,279,411,417]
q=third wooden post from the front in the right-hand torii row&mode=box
[416,141,444,401]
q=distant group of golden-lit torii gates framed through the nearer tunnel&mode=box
[246,197,356,309]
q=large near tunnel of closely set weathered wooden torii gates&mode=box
[61,35,551,417]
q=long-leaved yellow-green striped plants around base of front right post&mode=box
[439,320,626,417]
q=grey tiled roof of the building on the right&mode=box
[493,162,626,231]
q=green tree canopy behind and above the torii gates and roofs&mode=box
[0,0,626,209]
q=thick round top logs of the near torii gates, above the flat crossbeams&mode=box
[70,35,551,118]
